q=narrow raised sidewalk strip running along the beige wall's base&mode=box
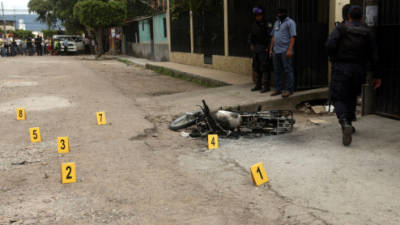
[118,56,251,87]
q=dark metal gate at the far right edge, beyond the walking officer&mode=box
[376,0,400,119]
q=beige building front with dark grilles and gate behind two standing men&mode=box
[168,0,332,90]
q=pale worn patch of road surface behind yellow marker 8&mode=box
[0,96,72,113]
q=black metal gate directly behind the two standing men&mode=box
[228,0,330,90]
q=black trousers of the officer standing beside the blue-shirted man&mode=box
[253,51,272,89]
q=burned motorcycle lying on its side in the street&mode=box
[169,100,295,137]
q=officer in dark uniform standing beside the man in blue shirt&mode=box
[249,6,272,93]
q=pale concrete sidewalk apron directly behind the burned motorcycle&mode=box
[136,84,328,115]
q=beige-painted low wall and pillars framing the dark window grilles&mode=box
[168,0,350,76]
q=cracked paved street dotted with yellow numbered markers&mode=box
[0,56,400,225]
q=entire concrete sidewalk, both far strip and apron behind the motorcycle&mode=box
[118,56,328,115]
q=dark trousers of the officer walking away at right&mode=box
[330,63,366,123]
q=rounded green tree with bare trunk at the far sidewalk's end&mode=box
[74,0,127,57]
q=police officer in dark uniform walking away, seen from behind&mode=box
[326,6,381,146]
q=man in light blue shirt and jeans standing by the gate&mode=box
[269,9,297,98]
